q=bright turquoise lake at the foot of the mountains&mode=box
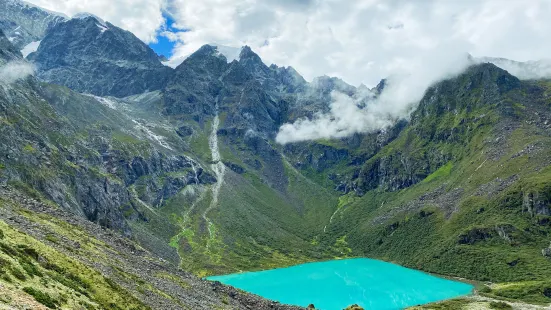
[207,258,473,310]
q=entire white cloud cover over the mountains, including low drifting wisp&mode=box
[22,0,551,142]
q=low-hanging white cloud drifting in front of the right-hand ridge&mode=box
[276,45,470,144]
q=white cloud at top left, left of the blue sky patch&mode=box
[27,0,166,43]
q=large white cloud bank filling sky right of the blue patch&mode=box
[166,0,551,85]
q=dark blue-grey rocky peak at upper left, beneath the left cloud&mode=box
[31,15,172,97]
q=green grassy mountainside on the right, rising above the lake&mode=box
[298,72,551,304]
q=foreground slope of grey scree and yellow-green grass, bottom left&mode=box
[0,185,300,309]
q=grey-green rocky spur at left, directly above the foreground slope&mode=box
[0,30,212,239]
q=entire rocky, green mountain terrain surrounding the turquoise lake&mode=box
[0,0,551,309]
